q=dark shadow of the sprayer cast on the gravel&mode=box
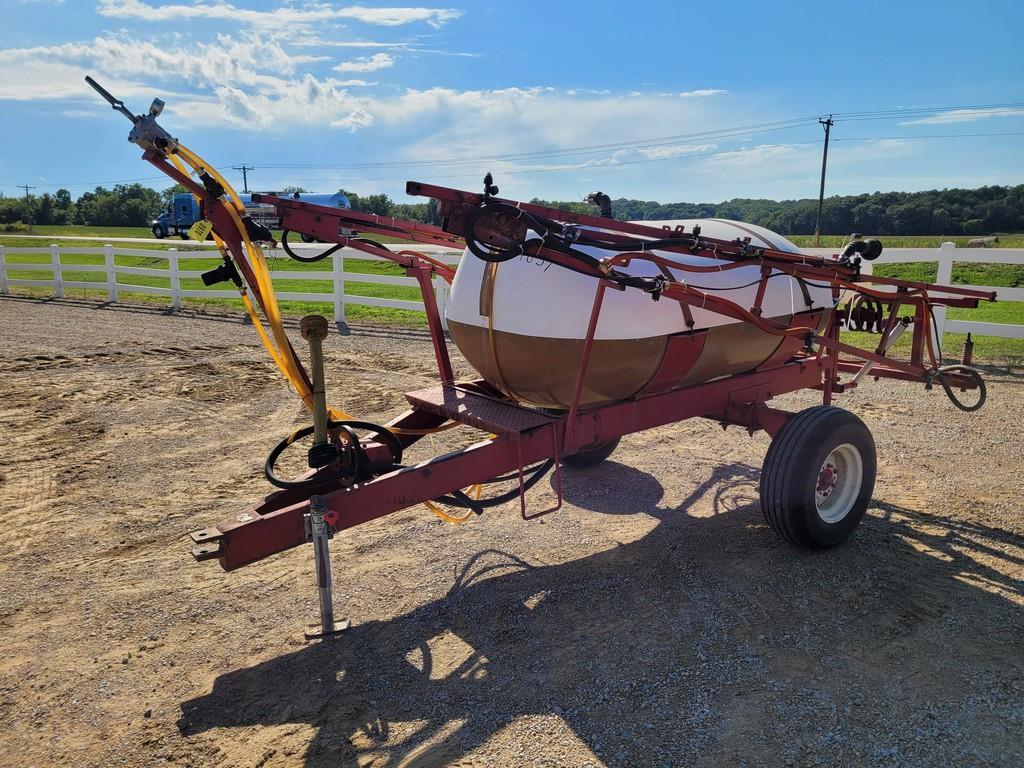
[179,461,1024,766]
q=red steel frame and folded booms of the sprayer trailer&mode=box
[163,173,995,570]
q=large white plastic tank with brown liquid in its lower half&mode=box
[446,219,835,409]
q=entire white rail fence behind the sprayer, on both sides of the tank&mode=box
[0,243,1024,339]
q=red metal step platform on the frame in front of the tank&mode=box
[406,384,560,437]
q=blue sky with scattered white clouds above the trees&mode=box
[0,0,1024,202]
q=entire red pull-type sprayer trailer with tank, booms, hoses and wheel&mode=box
[90,81,995,633]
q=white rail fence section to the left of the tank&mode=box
[0,245,461,329]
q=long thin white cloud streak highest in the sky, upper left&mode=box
[97,0,462,29]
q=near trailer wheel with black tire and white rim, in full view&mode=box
[761,406,878,549]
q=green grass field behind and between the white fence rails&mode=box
[0,226,1024,366]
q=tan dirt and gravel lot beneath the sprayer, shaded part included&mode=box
[0,299,1024,767]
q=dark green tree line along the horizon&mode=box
[0,183,1024,236]
